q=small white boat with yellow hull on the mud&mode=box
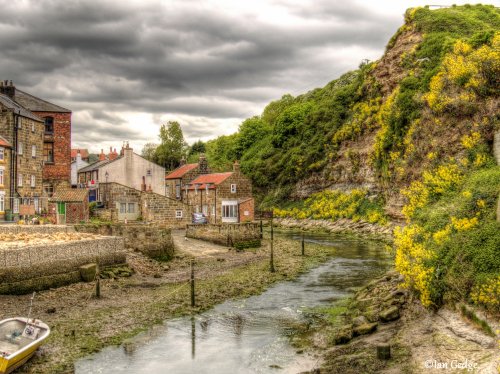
[0,317,50,374]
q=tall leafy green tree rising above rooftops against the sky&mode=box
[155,121,188,170]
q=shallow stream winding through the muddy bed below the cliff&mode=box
[75,232,389,374]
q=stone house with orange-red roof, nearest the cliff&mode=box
[184,161,254,223]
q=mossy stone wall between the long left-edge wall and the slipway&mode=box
[74,224,174,258]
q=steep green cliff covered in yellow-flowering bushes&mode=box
[197,5,500,313]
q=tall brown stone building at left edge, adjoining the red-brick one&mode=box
[0,90,46,216]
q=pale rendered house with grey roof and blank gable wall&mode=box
[78,144,165,204]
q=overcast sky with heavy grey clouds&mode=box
[0,0,499,152]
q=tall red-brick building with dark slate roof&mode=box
[0,81,71,196]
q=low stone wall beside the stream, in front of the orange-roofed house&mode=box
[186,223,260,249]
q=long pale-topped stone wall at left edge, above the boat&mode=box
[0,237,126,294]
